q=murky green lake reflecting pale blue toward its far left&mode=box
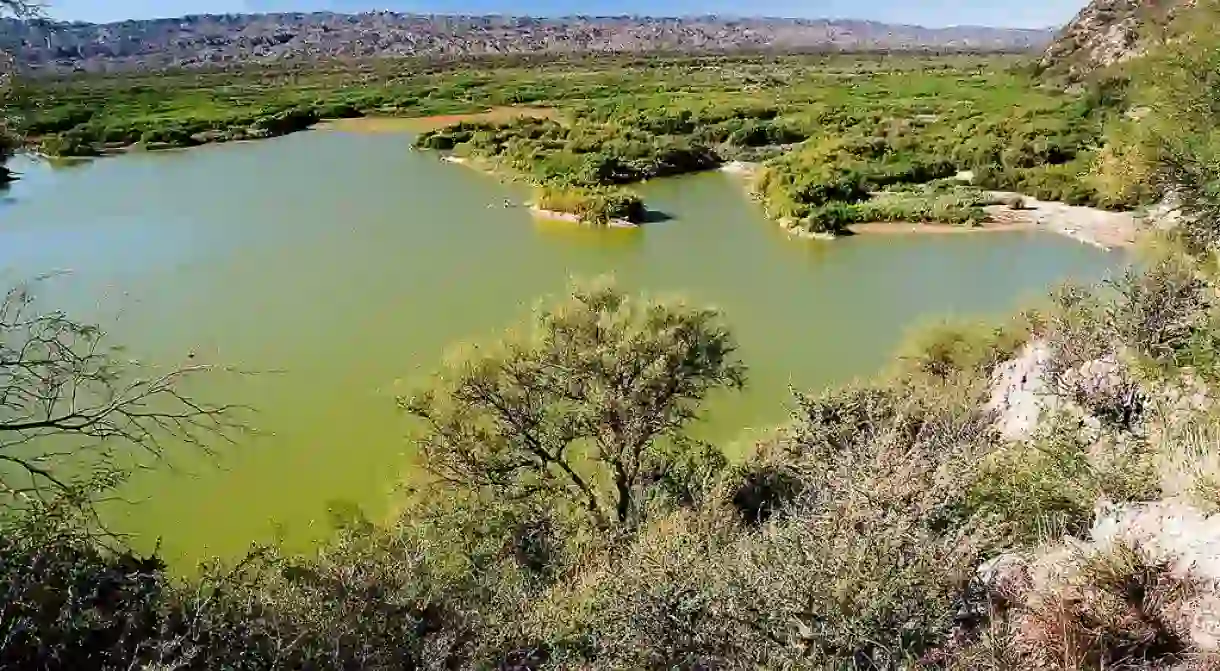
[0,132,1125,566]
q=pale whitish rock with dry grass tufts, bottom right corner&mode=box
[977,501,1220,670]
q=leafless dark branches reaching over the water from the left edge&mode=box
[0,285,242,507]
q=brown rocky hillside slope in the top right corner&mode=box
[1041,0,1194,81]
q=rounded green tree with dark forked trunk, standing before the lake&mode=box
[400,283,745,527]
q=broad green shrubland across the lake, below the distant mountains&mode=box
[16,49,1141,233]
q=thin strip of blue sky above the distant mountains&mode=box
[48,0,1087,28]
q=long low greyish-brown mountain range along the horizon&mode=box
[0,12,1054,71]
